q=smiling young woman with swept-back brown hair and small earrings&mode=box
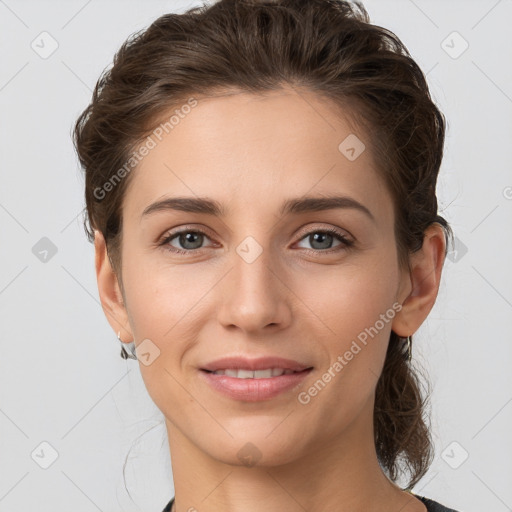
[75,0,460,512]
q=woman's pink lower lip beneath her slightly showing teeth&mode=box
[200,368,312,402]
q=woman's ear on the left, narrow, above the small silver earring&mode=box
[94,230,133,343]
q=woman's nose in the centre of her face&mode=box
[218,245,293,335]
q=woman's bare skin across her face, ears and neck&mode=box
[95,87,445,512]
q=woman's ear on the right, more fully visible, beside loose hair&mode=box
[392,222,446,338]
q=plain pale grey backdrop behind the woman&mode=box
[0,0,512,512]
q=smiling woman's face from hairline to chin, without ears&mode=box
[107,88,410,464]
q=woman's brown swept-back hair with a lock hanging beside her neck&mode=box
[74,0,453,489]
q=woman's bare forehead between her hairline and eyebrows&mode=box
[124,87,392,224]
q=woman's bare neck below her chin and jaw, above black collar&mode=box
[166,403,426,512]
